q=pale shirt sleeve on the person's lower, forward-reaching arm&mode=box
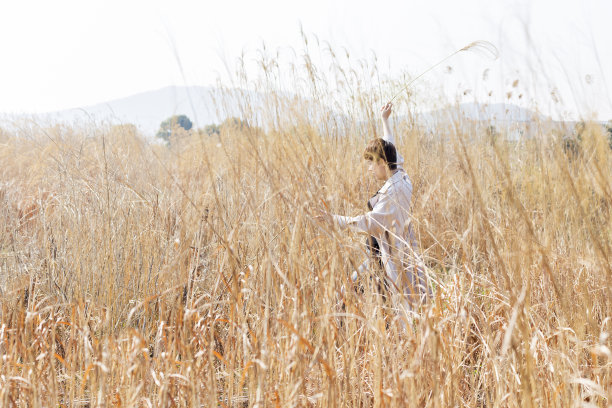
[334,194,398,236]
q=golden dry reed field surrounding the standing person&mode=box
[0,43,612,407]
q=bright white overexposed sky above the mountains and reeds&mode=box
[0,0,612,120]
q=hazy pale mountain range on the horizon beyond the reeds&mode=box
[0,86,542,137]
